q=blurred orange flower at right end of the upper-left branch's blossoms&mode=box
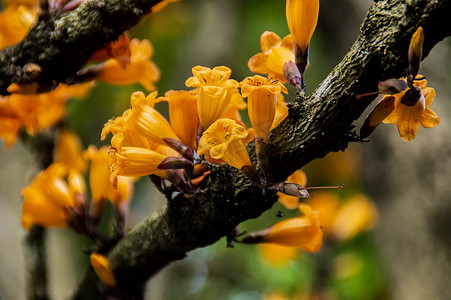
[96,39,160,91]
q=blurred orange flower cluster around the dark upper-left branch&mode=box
[0,1,162,146]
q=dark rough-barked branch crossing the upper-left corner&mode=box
[0,0,162,95]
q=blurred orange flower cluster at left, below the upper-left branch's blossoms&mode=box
[22,130,134,230]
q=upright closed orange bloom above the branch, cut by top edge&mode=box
[286,0,319,53]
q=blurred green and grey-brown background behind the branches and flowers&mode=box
[0,0,451,300]
